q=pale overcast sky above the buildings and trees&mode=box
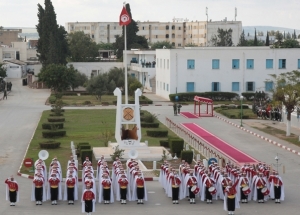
[0,0,300,29]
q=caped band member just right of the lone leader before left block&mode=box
[99,173,114,204]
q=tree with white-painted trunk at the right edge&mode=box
[271,70,300,136]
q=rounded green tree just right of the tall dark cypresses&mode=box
[68,31,99,62]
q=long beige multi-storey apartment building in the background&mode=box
[65,19,242,48]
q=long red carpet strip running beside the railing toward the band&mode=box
[181,123,258,163]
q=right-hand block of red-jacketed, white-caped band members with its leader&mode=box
[159,160,284,214]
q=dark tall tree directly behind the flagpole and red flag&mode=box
[114,4,148,58]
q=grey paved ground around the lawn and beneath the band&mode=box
[0,80,300,215]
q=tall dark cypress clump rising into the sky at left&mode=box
[36,0,68,66]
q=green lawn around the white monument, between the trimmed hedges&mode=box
[21,110,176,174]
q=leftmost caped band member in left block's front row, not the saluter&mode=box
[31,174,46,205]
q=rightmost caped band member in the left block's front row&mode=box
[132,172,148,204]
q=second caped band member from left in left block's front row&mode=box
[47,174,62,205]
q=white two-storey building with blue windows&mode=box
[156,47,300,99]
